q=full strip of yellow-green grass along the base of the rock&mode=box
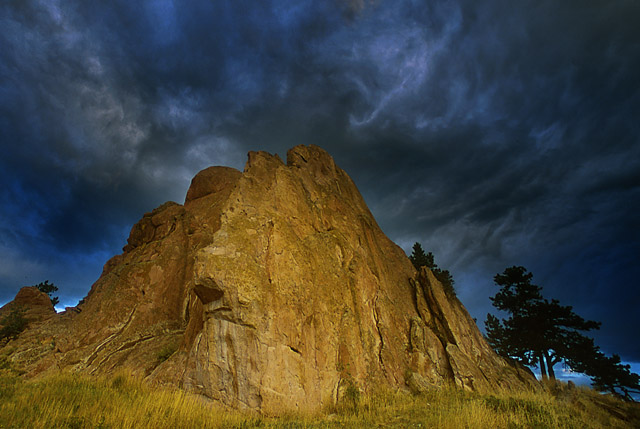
[0,371,640,429]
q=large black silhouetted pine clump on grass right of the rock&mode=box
[485,267,640,400]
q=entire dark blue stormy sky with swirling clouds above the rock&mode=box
[0,0,640,361]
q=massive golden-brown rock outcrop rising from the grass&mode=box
[0,146,536,411]
